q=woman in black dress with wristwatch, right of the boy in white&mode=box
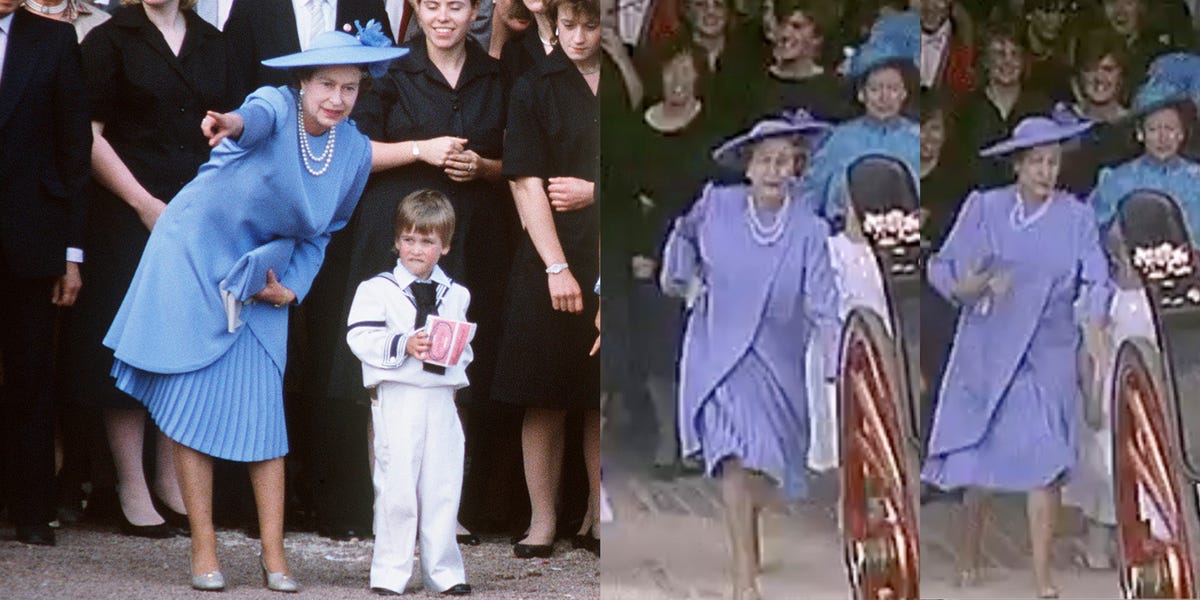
[492,0,600,558]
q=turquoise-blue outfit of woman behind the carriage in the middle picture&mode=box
[802,116,920,223]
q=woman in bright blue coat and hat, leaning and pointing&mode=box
[104,24,407,592]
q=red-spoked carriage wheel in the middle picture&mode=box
[838,311,919,600]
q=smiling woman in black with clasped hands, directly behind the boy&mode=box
[308,0,514,544]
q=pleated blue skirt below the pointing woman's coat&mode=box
[112,328,288,462]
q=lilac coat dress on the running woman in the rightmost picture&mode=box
[922,186,1112,491]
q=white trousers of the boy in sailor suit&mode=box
[371,382,467,593]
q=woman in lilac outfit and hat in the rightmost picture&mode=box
[922,116,1111,598]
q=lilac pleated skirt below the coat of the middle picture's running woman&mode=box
[697,349,809,499]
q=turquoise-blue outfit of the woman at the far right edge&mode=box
[1090,155,1200,240]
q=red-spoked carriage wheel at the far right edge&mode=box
[1114,344,1200,598]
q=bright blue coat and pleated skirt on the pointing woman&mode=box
[104,88,371,461]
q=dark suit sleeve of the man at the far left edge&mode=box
[53,28,91,249]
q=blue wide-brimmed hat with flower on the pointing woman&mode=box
[263,19,408,77]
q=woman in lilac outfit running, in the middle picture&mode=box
[661,113,838,600]
